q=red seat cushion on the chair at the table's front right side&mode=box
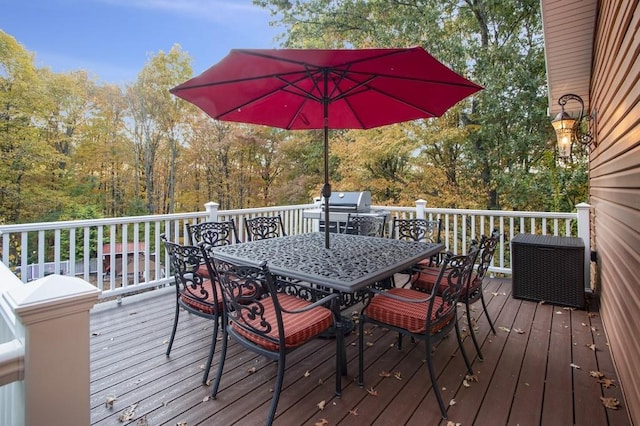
[365,288,456,334]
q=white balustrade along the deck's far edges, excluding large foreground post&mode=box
[0,200,589,298]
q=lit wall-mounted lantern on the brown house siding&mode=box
[551,93,595,158]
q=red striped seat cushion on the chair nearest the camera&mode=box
[231,293,333,351]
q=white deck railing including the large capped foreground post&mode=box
[0,200,590,425]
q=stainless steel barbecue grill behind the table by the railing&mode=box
[303,191,391,233]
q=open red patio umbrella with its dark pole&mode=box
[170,47,482,248]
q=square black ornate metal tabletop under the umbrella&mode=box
[213,232,444,293]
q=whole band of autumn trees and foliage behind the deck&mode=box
[0,0,588,228]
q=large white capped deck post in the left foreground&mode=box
[4,275,100,426]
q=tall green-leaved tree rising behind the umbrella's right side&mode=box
[254,0,581,209]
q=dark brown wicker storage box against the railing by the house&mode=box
[511,234,584,309]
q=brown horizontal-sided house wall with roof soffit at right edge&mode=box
[541,0,640,424]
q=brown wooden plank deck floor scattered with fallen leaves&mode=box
[91,279,630,426]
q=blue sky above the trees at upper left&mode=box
[0,0,282,84]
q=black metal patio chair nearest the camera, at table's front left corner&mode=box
[203,250,342,425]
